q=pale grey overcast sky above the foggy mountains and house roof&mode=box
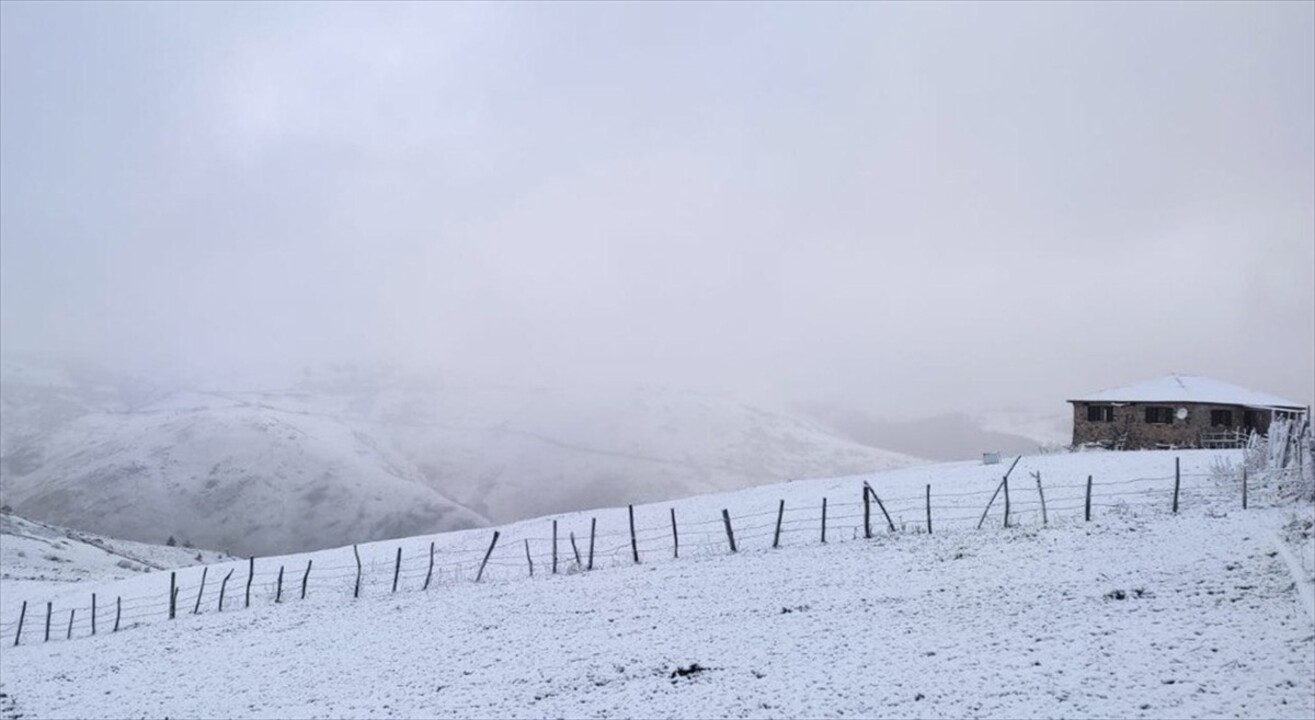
[0,1,1315,415]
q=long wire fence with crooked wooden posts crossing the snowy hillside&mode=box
[0,461,1295,645]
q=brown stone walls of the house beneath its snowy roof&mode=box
[1073,402,1270,449]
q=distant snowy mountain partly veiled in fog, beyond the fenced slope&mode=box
[0,361,918,554]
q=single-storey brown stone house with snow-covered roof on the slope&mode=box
[1069,374,1307,449]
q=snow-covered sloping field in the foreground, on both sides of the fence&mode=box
[0,451,1315,717]
